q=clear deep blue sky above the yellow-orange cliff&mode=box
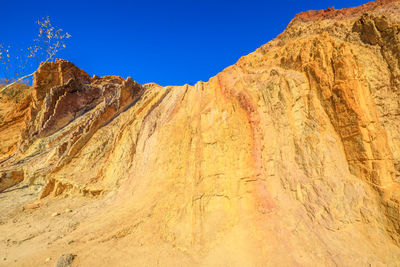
[0,0,368,85]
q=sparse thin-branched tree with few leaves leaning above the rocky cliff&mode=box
[0,17,71,93]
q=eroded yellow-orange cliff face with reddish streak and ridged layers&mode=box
[0,1,400,266]
